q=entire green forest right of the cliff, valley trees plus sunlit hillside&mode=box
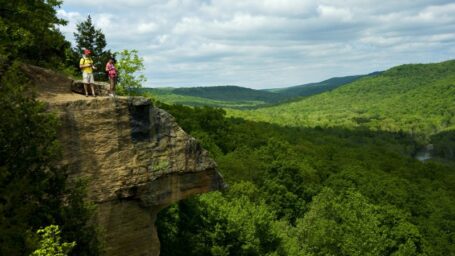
[151,61,455,255]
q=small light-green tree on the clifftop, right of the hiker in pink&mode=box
[117,50,147,94]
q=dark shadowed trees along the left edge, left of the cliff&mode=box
[0,0,102,256]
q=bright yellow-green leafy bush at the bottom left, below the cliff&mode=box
[31,225,76,256]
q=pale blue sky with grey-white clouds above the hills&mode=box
[58,0,455,89]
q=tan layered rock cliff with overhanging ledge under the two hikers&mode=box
[24,66,224,256]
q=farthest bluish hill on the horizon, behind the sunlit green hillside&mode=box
[265,72,381,99]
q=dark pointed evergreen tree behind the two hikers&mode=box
[74,15,112,80]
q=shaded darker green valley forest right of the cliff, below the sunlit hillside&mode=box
[157,105,455,256]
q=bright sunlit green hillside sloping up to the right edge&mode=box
[229,60,455,136]
